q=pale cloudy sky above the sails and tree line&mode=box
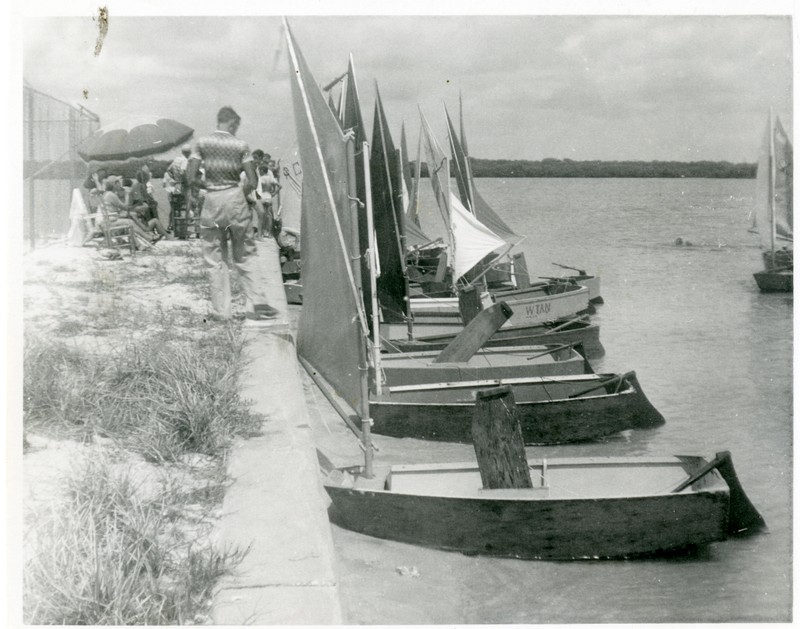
[20,1,793,162]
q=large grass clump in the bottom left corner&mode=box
[23,459,244,625]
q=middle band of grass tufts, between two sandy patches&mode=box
[23,325,262,461]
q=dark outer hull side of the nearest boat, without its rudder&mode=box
[325,454,729,560]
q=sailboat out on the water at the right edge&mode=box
[753,111,794,293]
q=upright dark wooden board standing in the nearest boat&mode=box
[472,385,533,489]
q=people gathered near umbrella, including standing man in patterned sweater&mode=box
[85,107,280,320]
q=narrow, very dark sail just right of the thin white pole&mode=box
[370,85,408,323]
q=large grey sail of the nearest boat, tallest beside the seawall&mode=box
[284,22,366,410]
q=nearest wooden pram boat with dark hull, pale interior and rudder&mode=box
[324,452,765,560]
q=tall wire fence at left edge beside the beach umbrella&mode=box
[23,84,100,248]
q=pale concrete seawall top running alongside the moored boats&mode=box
[212,239,342,625]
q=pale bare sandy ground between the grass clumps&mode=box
[21,240,231,622]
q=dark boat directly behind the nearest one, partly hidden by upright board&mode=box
[369,373,664,445]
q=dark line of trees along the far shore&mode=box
[23,158,756,179]
